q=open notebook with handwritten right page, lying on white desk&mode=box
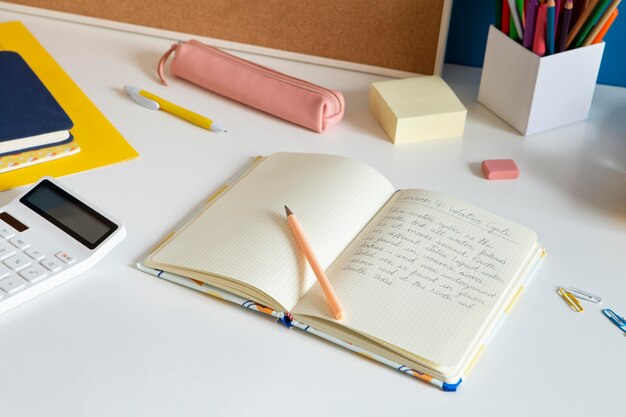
[140,153,543,390]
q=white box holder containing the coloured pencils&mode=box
[478,26,604,135]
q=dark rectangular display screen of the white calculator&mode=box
[20,180,118,249]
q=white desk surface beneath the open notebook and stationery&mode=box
[0,12,626,417]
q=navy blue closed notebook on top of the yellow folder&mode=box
[0,51,74,154]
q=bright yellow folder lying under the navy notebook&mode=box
[0,22,139,190]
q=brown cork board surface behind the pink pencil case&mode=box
[2,0,451,74]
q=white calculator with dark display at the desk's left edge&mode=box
[0,177,126,313]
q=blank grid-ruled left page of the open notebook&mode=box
[147,153,394,310]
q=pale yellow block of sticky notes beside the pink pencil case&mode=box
[369,75,467,143]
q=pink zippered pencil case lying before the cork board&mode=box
[158,40,345,133]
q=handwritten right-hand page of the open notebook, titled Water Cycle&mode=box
[294,190,537,369]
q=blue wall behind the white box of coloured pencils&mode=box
[446,0,626,87]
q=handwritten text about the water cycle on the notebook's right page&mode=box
[342,194,519,310]
